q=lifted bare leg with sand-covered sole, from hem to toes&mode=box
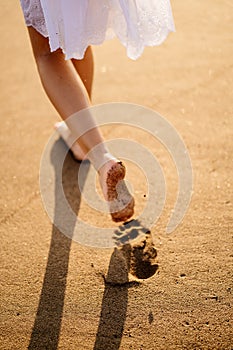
[29,27,134,221]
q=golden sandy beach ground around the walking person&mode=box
[0,0,233,350]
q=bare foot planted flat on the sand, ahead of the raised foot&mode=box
[54,121,86,162]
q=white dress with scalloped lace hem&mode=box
[20,0,175,59]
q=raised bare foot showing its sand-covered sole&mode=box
[99,160,134,222]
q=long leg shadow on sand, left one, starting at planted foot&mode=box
[28,140,88,350]
